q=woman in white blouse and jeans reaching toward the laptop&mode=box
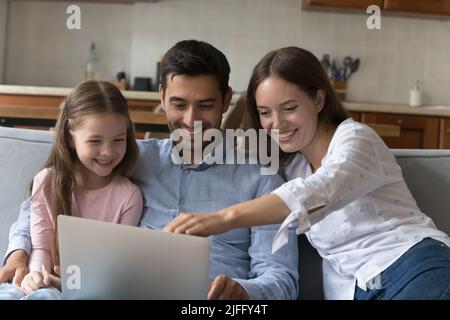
[166,47,450,299]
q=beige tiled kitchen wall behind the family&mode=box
[2,0,450,105]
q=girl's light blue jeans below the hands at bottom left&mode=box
[0,283,62,300]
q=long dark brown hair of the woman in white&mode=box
[247,47,348,165]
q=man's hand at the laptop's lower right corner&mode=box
[208,275,248,300]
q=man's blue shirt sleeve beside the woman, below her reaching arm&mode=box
[234,175,298,300]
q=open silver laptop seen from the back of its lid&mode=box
[58,215,209,300]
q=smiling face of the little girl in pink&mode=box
[70,113,128,184]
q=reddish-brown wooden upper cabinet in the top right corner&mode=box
[383,0,450,15]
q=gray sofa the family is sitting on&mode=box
[0,127,450,299]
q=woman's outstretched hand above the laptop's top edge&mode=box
[164,212,233,237]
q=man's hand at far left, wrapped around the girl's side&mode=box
[0,250,28,287]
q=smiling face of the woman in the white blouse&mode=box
[255,76,325,153]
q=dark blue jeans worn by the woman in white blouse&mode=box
[355,238,450,300]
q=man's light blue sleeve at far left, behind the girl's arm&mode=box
[3,199,31,265]
